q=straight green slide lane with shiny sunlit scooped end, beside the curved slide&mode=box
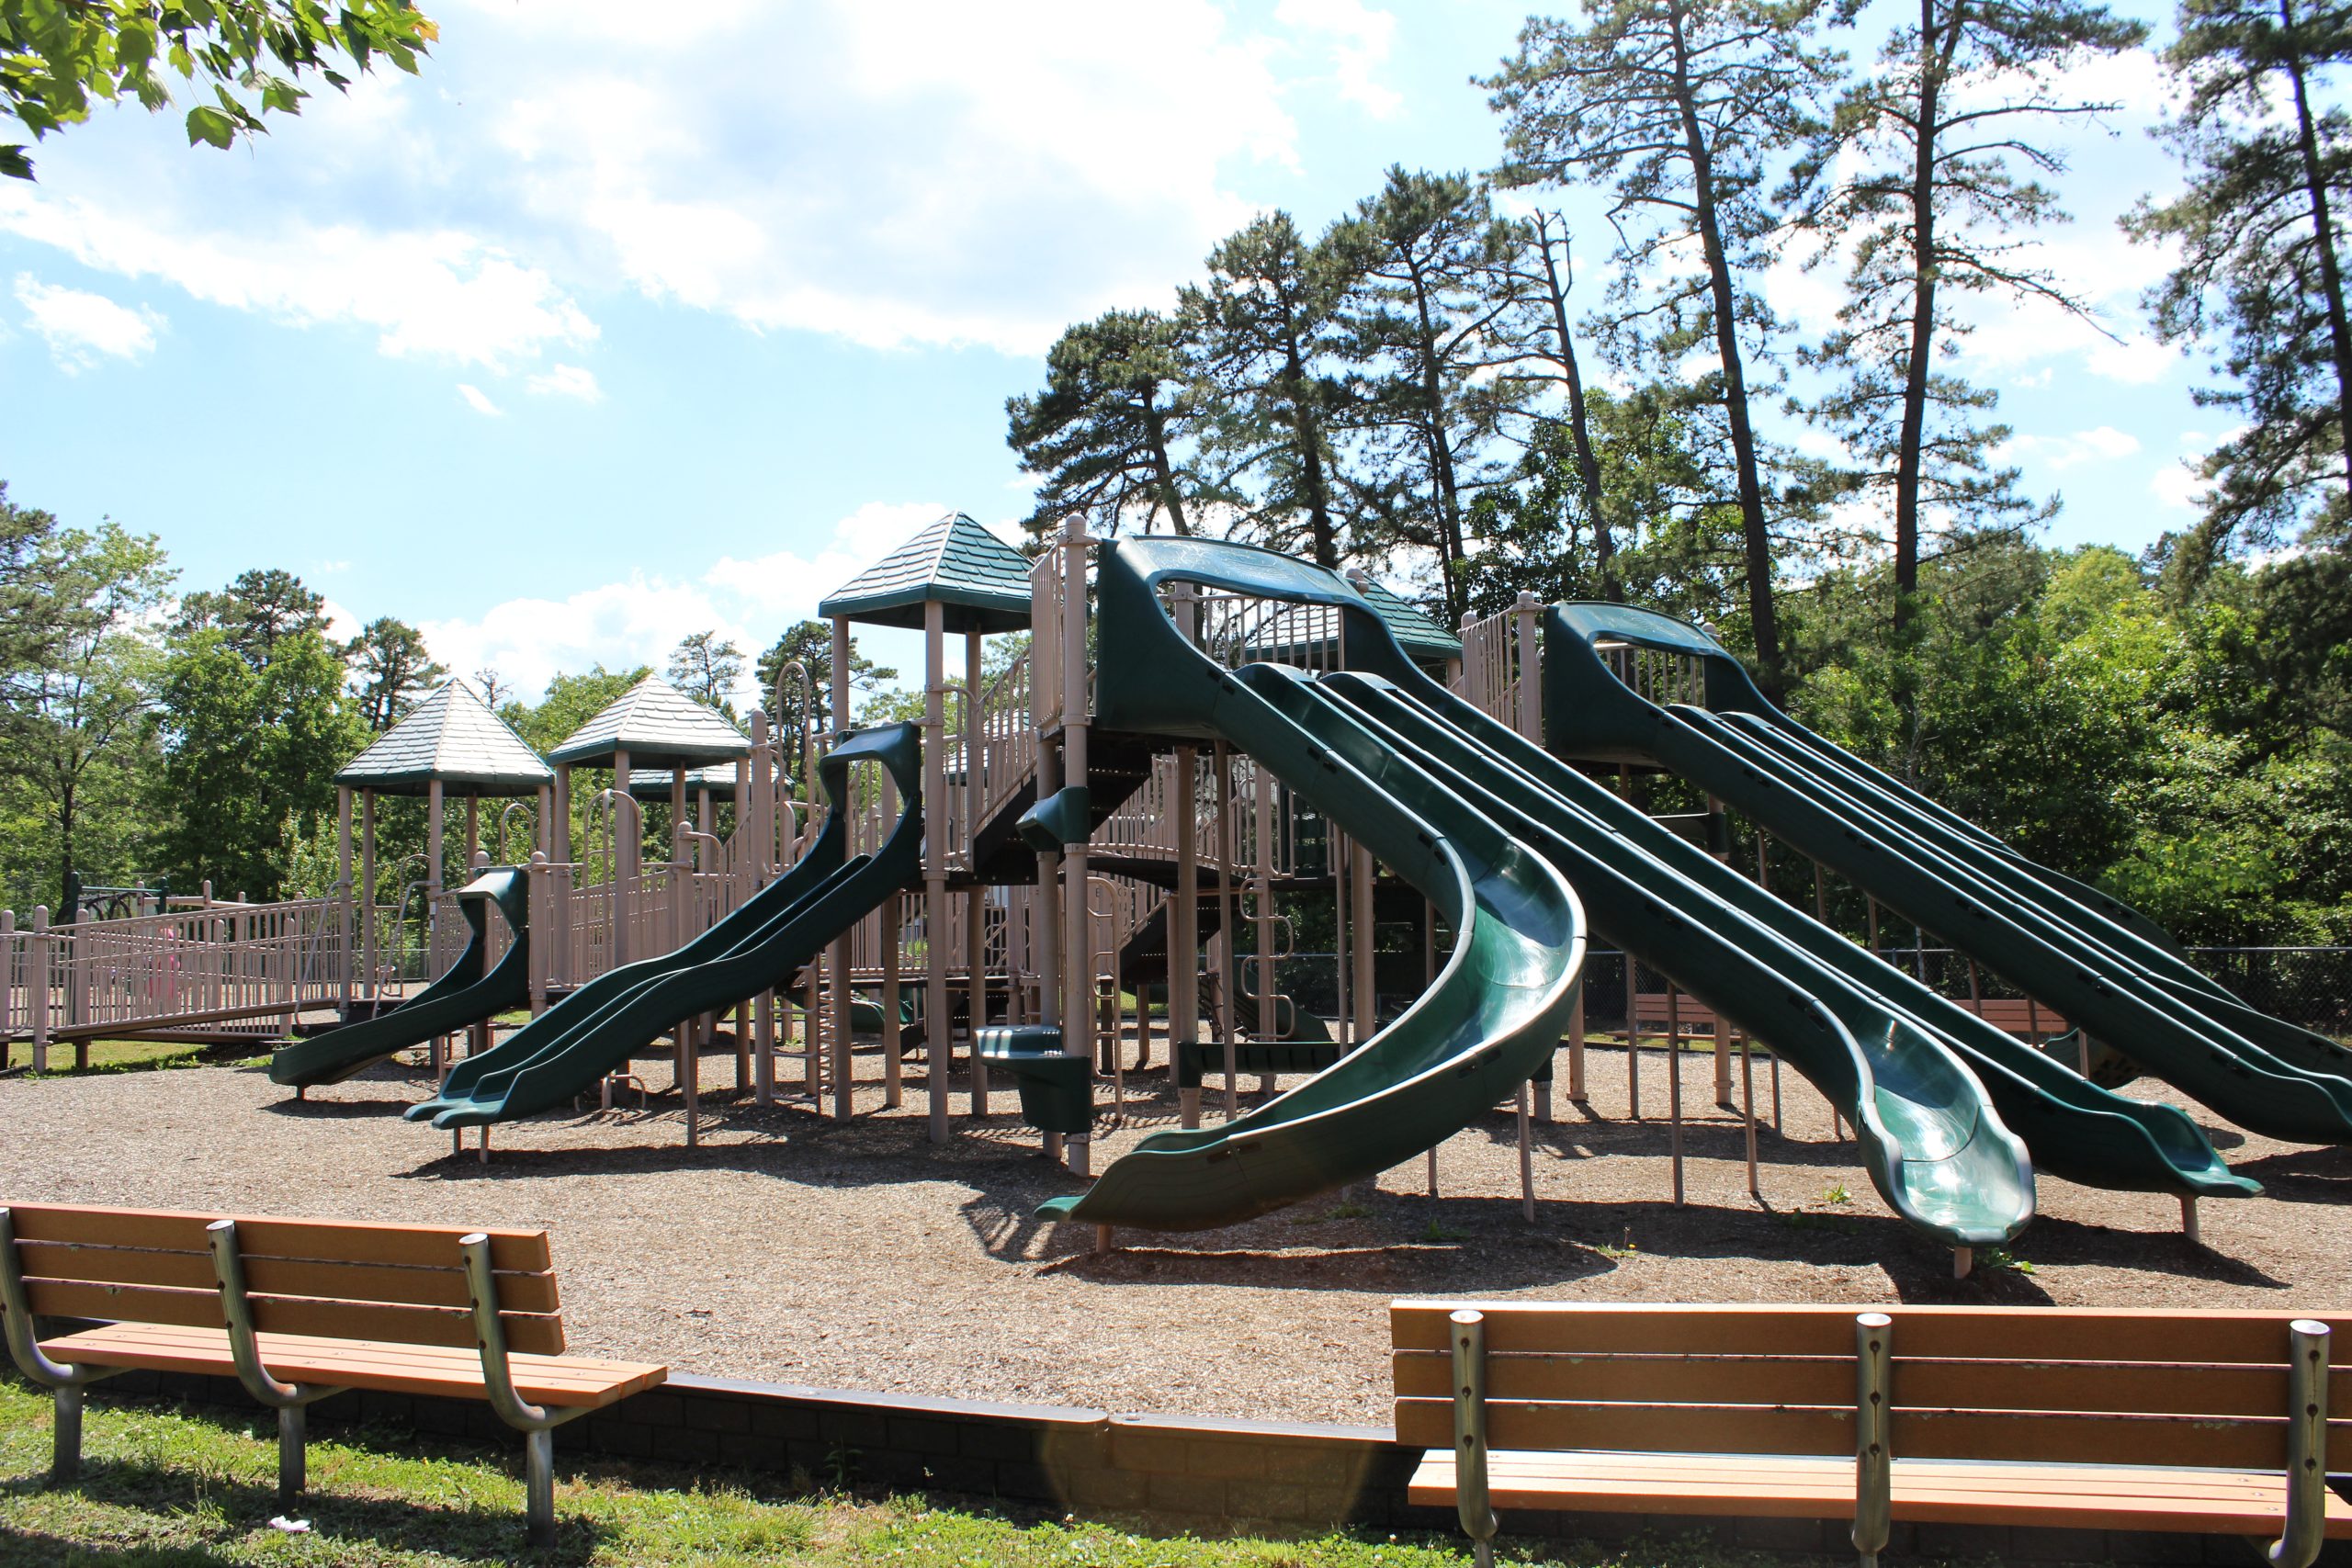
[1327,672,2032,1246]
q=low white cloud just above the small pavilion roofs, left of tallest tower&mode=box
[421,501,948,710]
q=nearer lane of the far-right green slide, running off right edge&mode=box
[1658,710,2352,1143]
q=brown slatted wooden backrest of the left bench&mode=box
[7,1203,564,1357]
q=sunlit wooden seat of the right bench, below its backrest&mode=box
[1408,1448,2352,1538]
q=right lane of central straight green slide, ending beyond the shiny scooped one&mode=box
[1336,659,2260,1197]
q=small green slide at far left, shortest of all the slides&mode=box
[270,865,532,1089]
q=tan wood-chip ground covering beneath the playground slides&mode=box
[0,1051,2352,1425]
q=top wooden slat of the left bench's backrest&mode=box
[7,1203,553,1274]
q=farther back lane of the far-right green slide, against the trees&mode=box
[1691,710,2352,1079]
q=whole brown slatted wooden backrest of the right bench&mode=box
[1390,1300,2352,1472]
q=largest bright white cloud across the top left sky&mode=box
[0,0,1345,359]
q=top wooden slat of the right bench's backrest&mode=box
[1387,1300,2352,1366]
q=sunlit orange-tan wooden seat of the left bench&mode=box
[42,1324,668,1408]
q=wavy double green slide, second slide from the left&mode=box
[407,724,922,1128]
